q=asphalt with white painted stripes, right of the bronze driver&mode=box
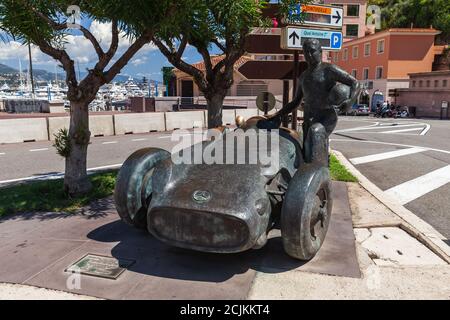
[331,117,450,239]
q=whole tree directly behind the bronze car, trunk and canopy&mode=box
[154,0,267,128]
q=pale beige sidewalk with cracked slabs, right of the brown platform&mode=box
[249,183,450,300]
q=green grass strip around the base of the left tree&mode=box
[0,171,117,217]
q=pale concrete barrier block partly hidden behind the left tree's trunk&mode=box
[48,115,114,140]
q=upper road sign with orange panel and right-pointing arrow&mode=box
[288,4,344,29]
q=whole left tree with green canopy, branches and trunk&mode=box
[0,0,185,194]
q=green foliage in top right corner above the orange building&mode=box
[369,0,450,43]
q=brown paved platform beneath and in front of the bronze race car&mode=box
[0,183,360,299]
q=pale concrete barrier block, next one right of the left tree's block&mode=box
[114,112,166,134]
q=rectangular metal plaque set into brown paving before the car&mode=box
[65,254,136,280]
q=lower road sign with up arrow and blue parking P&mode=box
[281,27,343,50]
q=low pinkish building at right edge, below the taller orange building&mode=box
[395,70,450,119]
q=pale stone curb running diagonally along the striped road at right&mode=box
[332,150,450,264]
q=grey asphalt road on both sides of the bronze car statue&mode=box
[0,117,450,239]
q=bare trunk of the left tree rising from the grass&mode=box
[64,101,92,196]
